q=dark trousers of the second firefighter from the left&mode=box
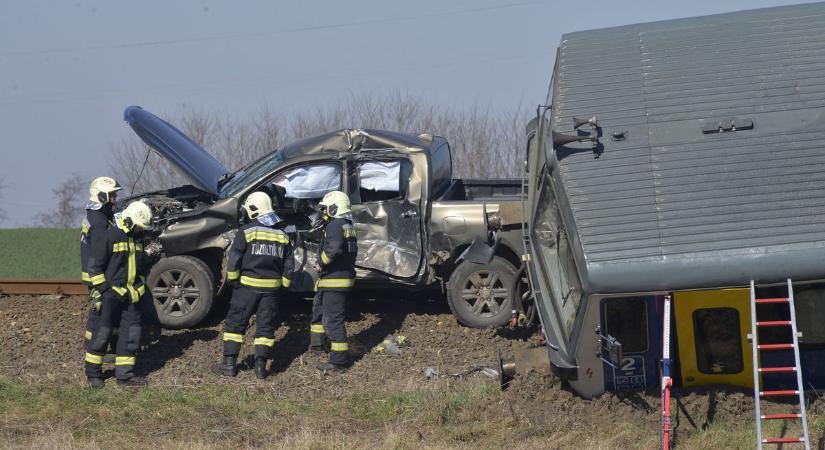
[84,289,143,380]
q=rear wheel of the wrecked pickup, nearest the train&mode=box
[447,256,516,328]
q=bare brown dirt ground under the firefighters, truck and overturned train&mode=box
[0,295,825,448]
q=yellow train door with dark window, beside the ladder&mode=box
[673,289,753,388]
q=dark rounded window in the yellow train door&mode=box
[693,308,744,375]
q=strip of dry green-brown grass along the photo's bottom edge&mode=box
[0,379,825,450]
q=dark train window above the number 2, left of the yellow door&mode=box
[604,297,648,353]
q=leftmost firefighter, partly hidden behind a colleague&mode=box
[80,177,122,358]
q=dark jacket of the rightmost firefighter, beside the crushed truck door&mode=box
[315,218,358,290]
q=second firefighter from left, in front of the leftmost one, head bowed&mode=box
[85,201,152,388]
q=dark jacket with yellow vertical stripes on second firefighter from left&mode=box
[88,218,151,303]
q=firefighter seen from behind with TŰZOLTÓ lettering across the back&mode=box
[212,192,293,380]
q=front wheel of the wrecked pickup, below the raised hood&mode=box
[146,256,215,328]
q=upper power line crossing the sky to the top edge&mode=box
[0,0,549,56]
